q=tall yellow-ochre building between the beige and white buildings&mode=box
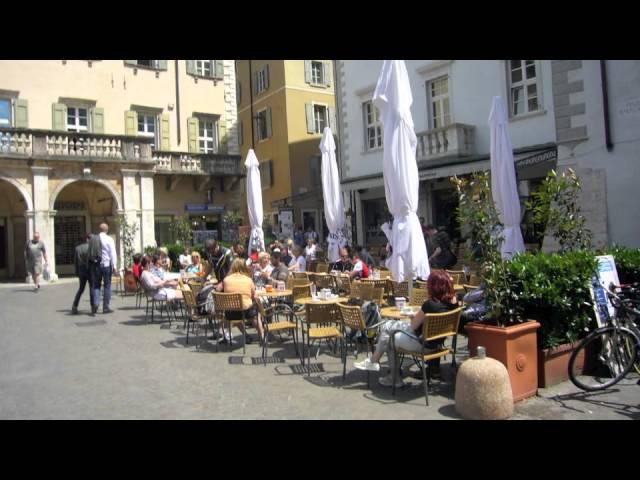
[236,60,336,244]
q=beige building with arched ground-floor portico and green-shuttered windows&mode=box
[0,60,244,278]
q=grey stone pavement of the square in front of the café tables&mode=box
[0,279,640,419]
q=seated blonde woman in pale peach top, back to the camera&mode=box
[216,258,264,343]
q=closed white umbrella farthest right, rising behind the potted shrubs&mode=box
[489,97,525,259]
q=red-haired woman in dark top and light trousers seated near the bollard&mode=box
[354,270,458,387]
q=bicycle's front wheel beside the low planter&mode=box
[569,327,639,391]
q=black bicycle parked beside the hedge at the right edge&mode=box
[569,285,640,391]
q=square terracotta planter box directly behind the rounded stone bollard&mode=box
[465,320,540,402]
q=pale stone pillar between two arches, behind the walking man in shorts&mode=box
[27,167,58,281]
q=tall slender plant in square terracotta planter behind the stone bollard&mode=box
[452,172,540,401]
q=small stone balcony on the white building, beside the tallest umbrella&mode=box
[416,123,475,165]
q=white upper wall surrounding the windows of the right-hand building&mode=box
[338,60,555,184]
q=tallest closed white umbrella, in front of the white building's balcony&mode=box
[373,60,430,284]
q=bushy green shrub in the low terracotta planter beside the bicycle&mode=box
[514,168,597,387]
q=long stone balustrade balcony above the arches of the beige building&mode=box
[0,128,242,176]
